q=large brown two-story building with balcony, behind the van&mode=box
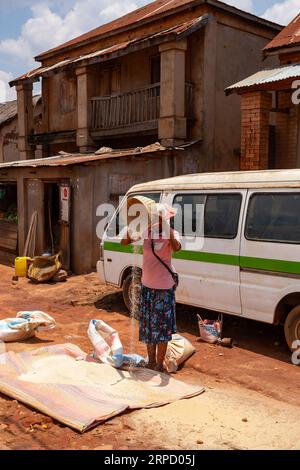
[0,0,281,273]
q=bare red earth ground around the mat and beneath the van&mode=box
[0,266,300,450]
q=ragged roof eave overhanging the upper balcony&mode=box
[9,14,211,87]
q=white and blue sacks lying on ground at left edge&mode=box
[0,310,55,343]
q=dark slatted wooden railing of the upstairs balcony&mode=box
[89,83,194,138]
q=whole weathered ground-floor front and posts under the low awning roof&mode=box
[0,153,178,274]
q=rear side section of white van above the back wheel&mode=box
[240,189,300,323]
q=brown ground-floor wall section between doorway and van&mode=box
[72,154,176,272]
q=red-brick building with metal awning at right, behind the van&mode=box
[226,14,300,170]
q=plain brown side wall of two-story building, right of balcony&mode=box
[210,17,277,171]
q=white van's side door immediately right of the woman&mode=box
[165,190,247,315]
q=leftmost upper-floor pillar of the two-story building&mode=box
[16,82,34,160]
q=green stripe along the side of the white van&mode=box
[104,242,300,274]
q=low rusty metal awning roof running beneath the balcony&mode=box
[0,143,168,170]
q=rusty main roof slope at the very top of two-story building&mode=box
[36,0,279,61]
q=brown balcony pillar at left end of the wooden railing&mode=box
[76,67,96,153]
